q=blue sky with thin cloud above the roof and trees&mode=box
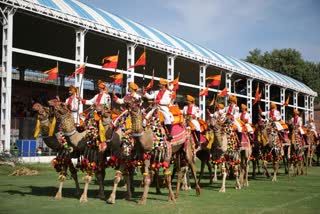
[80,0,320,62]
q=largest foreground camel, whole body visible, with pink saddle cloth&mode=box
[110,96,200,205]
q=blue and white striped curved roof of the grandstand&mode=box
[0,0,317,96]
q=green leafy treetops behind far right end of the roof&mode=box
[245,48,320,98]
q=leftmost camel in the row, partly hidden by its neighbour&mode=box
[33,103,80,200]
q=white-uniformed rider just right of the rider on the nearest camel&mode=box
[182,95,201,146]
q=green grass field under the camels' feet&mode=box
[0,164,320,214]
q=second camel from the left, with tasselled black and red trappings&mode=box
[49,99,105,203]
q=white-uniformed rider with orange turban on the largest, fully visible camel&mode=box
[143,78,173,141]
